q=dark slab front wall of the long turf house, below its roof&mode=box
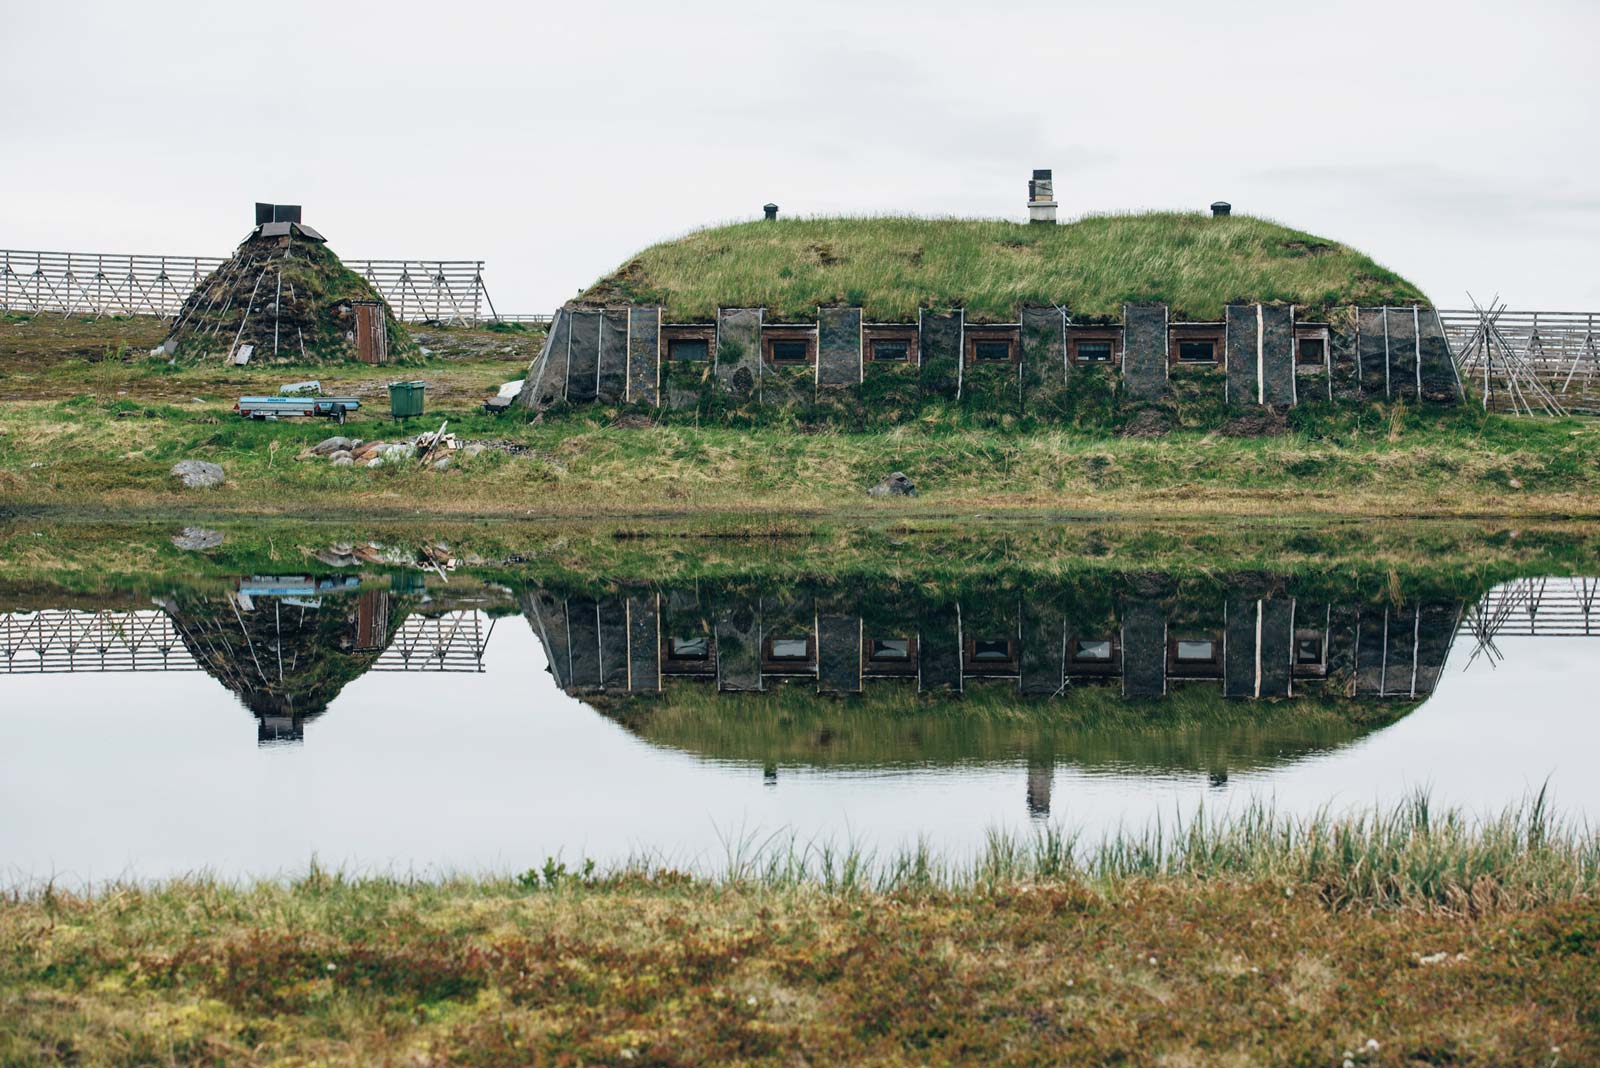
[517,304,1462,422]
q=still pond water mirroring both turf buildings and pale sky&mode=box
[0,562,1600,884]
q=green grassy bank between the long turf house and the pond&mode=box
[0,396,1600,516]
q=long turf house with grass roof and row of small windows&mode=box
[518,213,1462,432]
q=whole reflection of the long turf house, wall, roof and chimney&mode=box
[522,576,1461,815]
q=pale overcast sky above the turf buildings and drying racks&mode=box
[0,0,1600,312]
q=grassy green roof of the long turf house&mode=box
[581,213,1427,321]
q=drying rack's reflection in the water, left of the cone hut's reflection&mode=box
[0,608,198,675]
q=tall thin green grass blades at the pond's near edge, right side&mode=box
[675,790,1600,913]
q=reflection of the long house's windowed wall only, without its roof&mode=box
[523,592,1461,699]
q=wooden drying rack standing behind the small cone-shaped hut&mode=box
[0,249,505,323]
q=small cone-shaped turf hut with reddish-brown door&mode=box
[162,203,414,365]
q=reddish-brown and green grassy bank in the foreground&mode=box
[0,801,1600,1066]
